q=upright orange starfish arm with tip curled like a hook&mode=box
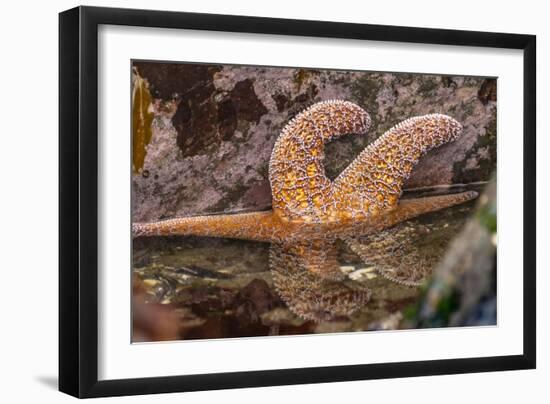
[269,100,370,222]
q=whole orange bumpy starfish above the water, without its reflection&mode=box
[132,101,477,242]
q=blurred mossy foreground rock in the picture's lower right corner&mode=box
[407,181,497,328]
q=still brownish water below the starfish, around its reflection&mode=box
[132,187,479,342]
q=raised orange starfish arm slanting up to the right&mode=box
[334,114,462,217]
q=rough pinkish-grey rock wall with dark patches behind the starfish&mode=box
[132,62,496,221]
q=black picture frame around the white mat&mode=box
[59,7,536,398]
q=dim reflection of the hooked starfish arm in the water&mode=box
[269,244,370,321]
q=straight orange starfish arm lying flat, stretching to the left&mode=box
[132,211,280,241]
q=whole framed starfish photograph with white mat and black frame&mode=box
[59,7,536,397]
